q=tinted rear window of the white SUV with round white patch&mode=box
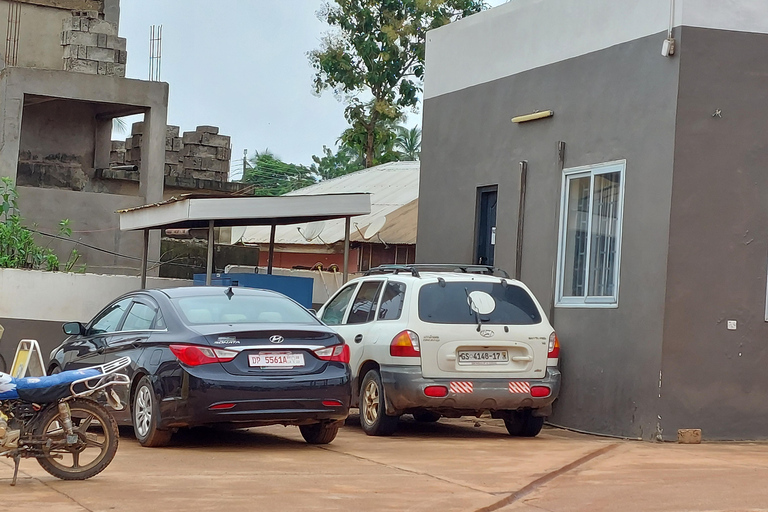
[419,281,541,325]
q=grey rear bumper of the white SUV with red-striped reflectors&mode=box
[381,366,560,416]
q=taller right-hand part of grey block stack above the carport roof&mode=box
[181,126,232,181]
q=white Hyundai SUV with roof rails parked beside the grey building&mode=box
[318,265,560,437]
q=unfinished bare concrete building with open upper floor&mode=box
[0,0,168,273]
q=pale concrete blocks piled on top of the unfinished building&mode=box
[61,11,128,77]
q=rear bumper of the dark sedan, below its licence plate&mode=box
[160,363,351,428]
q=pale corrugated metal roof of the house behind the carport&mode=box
[237,162,420,245]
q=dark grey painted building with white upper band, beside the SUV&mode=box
[417,0,768,440]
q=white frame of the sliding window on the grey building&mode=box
[555,160,627,308]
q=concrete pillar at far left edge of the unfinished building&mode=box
[0,76,24,184]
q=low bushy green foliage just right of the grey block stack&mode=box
[241,149,316,196]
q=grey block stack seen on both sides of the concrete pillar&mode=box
[110,122,232,182]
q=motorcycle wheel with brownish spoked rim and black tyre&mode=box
[35,398,119,480]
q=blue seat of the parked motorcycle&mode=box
[0,368,101,403]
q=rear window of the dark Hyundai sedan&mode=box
[173,293,318,324]
